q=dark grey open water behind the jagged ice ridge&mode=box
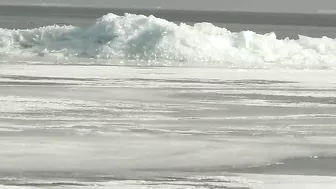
[0,6,336,38]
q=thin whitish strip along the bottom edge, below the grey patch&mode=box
[0,174,336,189]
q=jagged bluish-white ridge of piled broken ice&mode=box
[0,13,336,68]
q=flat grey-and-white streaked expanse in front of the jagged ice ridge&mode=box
[0,64,336,188]
